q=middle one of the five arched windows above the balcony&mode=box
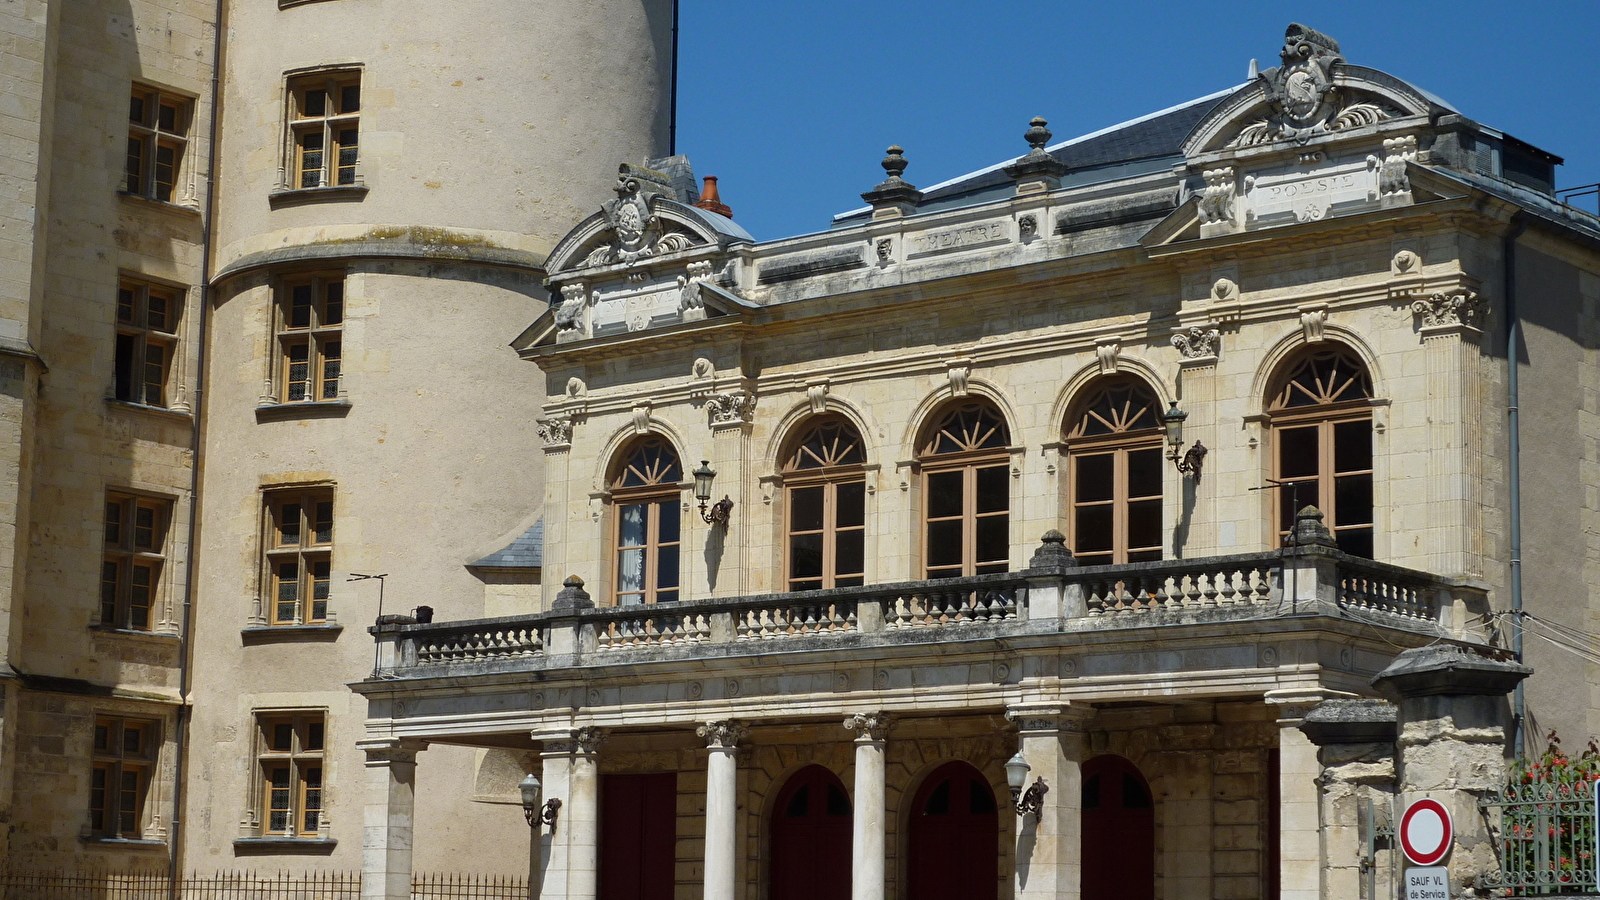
[917,400,1011,578]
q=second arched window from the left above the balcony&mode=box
[782,416,867,591]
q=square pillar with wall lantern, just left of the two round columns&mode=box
[534,727,605,900]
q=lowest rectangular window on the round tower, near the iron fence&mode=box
[256,711,326,838]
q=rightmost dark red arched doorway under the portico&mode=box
[1083,756,1155,900]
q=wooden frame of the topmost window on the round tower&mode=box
[280,67,365,191]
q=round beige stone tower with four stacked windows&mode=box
[182,0,674,874]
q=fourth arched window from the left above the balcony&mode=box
[1067,378,1166,565]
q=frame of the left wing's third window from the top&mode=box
[98,490,173,633]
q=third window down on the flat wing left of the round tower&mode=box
[99,493,173,631]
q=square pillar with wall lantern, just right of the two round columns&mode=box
[1002,703,1094,900]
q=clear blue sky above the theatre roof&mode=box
[677,0,1600,240]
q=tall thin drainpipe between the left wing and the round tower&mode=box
[166,0,226,883]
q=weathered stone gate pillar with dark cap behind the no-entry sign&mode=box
[1373,644,1533,895]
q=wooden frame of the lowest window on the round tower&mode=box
[250,709,328,841]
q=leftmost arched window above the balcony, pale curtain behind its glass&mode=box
[611,437,683,605]
